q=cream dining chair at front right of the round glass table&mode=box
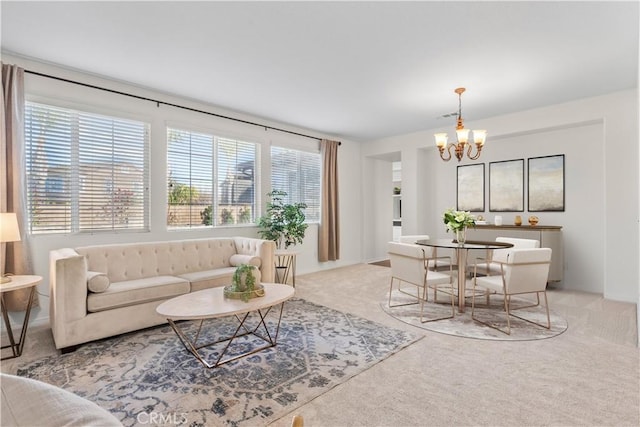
[471,248,551,335]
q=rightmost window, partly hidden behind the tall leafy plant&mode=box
[271,147,321,222]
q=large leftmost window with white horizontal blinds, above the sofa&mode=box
[25,102,149,234]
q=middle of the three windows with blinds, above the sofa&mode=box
[167,128,258,228]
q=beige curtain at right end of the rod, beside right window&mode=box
[318,139,340,262]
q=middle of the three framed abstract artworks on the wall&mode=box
[489,159,524,212]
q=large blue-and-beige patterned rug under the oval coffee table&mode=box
[17,298,423,426]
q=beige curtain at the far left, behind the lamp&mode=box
[0,64,37,311]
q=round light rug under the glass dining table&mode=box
[380,288,568,341]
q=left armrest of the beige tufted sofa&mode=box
[49,248,88,348]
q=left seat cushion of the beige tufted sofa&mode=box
[87,276,190,312]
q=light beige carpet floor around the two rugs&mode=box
[2,264,640,427]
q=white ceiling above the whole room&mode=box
[0,0,639,141]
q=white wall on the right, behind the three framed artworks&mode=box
[362,90,639,303]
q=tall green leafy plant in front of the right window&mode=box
[257,190,307,249]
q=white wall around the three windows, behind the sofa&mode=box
[3,55,362,324]
